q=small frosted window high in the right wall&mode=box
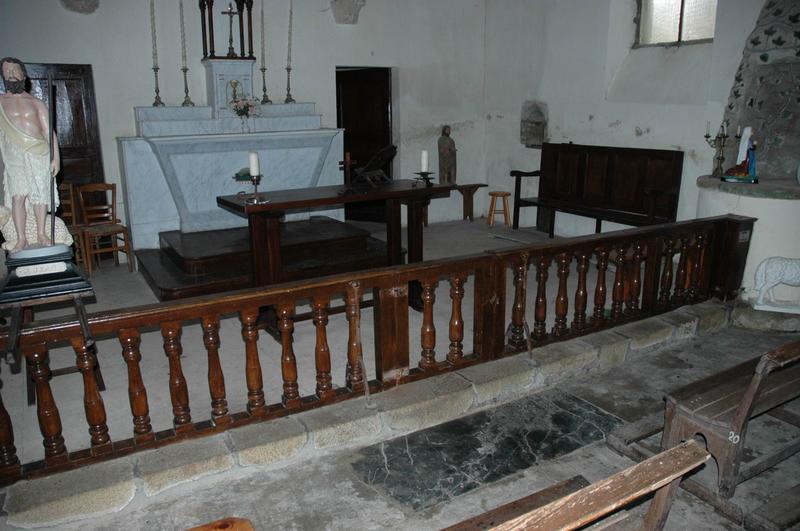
[636,0,717,46]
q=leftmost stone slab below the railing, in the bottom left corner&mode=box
[4,459,136,528]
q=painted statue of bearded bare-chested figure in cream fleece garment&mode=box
[0,57,66,253]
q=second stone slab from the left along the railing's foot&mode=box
[136,435,233,496]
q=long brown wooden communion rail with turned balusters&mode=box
[0,215,755,483]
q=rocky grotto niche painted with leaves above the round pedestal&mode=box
[725,0,800,182]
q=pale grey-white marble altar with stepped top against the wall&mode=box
[117,61,343,250]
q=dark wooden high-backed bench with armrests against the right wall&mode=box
[510,142,683,238]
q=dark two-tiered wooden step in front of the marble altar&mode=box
[136,216,394,301]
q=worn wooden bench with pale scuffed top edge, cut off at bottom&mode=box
[447,441,709,531]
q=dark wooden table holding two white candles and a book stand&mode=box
[217,180,455,286]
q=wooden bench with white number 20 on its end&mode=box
[661,341,800,498]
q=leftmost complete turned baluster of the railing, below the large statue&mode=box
[24,343,67,465]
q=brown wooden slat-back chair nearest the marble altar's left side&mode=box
[78,183,133,276]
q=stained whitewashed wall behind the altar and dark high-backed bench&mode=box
[0,0,762,231]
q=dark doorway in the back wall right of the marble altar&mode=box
[336,66,392,221]
